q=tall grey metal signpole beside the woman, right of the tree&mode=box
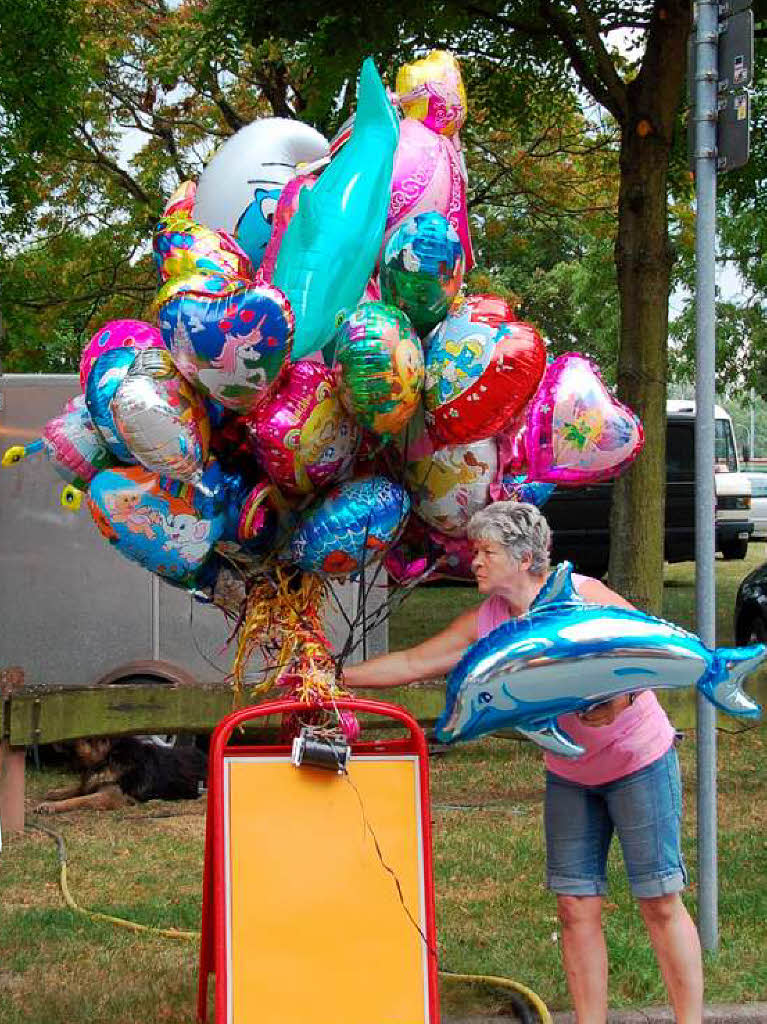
[694,0,719,949]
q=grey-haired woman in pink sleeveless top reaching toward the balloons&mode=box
[344,502,702,1024]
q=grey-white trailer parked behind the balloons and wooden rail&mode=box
[0,374,388,686]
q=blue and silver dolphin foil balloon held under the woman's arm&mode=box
[435,562,767,757]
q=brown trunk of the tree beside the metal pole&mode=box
[609,0,691,614]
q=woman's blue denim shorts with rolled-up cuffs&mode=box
[545,746,687,898]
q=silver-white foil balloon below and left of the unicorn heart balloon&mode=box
[112,348,210,483]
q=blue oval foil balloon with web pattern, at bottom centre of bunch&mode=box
[286,476,411,577]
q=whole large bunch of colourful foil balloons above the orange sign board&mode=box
[5,51,643,614]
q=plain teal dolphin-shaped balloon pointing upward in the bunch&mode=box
[272,57,399,359]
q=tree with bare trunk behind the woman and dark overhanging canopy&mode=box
[208,0,692,610]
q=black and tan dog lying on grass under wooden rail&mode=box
[35,736,208,814]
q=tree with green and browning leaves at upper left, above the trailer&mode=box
[0,0,284,371]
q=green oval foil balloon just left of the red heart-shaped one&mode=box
[335,302,424,435]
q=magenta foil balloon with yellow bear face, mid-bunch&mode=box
[246,359,361,495]
